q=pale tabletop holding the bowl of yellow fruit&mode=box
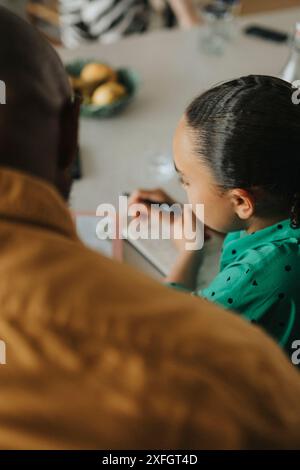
[58,8,300,276]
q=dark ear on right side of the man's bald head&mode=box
[58,96,81,171]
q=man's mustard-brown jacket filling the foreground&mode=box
[0,169,300,449]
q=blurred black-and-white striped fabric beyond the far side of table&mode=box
[59,0,149,47]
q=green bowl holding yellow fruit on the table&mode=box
[65,59,139,118]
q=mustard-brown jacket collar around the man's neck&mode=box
[0,167,77,239]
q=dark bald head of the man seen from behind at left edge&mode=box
[0,7,79,197]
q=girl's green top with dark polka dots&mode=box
[170,219,300,362]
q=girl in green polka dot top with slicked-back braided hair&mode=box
[132,75,300,353]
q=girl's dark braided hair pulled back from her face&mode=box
[186,75,300,228]
